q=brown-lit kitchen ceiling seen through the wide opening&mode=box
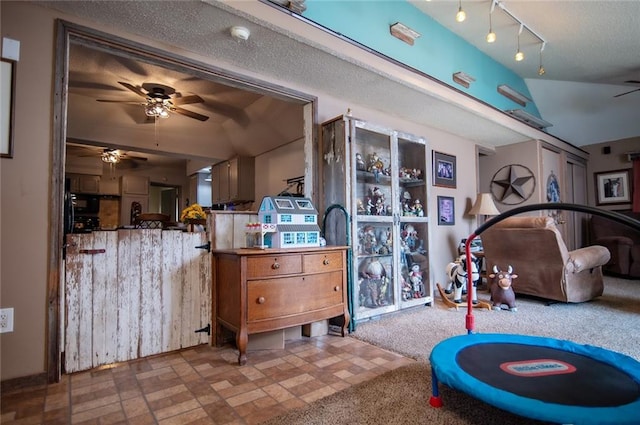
[67,43,303,167]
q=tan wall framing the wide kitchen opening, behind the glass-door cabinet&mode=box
[0,1,478,380]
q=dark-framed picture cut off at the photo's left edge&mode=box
[0,58,16,158]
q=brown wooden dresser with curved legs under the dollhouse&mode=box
[211,246,349,365]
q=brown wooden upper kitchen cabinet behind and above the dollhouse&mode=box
[211,156,255,204]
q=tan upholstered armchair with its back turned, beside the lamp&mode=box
[481,217,610,302]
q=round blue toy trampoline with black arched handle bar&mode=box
[430,203,640,425]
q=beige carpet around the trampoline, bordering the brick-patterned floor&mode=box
[265,277,640,425]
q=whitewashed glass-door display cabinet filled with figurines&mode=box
[322,117,433,321]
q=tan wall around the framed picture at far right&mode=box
[584,136,640,210]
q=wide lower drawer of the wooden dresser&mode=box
[247,271,344,322]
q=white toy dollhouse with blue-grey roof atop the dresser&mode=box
[258,196,320,248]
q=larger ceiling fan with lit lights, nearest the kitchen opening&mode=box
[97,81,209,121]
